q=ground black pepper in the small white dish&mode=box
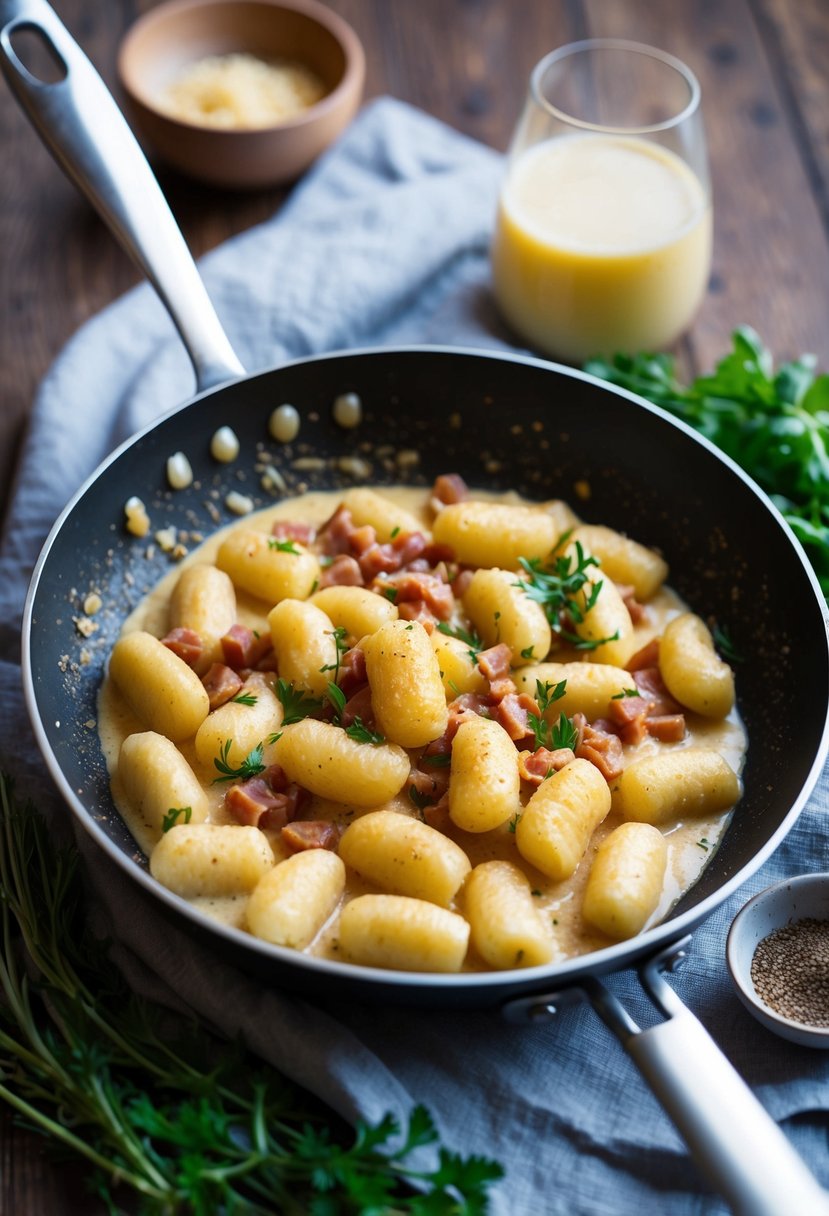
[751,917,829,1026]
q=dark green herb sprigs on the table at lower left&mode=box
[0,773,503,1216]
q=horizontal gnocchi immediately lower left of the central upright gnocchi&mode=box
[273,717,411,807]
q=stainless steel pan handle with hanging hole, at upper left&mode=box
[0,0,244,392]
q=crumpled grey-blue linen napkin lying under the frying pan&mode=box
[0,98,829,1216]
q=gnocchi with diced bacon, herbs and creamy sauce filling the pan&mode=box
[98,478,745,974]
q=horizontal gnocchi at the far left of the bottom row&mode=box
[150,823,275,900]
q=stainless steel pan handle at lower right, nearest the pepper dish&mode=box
[503,939,829,1216]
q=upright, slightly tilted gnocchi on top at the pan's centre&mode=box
[362,620,449,748]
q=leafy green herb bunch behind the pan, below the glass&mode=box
[585,326,829,598]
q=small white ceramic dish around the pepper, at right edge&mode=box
[726,873,829,1048]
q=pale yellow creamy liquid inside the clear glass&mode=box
[492,135,711,362]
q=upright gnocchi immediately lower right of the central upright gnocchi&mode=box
[449,717,521,832]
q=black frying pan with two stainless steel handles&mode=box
[0,0,829,1216]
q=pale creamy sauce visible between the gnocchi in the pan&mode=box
[98,486,746,970]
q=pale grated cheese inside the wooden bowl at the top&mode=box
[160,52,327,129]
